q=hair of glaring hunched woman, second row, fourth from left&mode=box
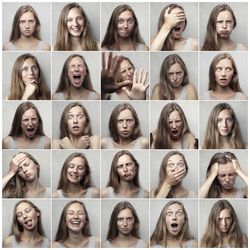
[159,54,189,100]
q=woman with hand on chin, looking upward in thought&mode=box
[8,54,51,100]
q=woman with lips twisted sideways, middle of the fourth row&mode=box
[101,150,149,198]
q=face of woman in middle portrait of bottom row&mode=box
[117,208,135,236]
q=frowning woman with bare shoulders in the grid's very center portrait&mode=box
[101,103,148,149]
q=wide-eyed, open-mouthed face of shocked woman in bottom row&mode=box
[165,203,185,236]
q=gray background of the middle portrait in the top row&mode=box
[101,2,149,46]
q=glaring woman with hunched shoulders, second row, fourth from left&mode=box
[151,54,197,100]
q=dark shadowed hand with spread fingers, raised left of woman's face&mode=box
[101,52,131,94]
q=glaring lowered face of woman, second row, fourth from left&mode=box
[168,63,184,88]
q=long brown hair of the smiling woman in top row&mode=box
[54,3,98,50]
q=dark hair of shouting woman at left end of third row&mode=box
[8,101,45,138]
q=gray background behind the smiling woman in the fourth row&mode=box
[52,149,100,192]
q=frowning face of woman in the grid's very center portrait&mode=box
[117,109,135,139]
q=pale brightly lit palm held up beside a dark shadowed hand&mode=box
[122,69,149,100]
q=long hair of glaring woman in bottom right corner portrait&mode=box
[201,200,244,248]
